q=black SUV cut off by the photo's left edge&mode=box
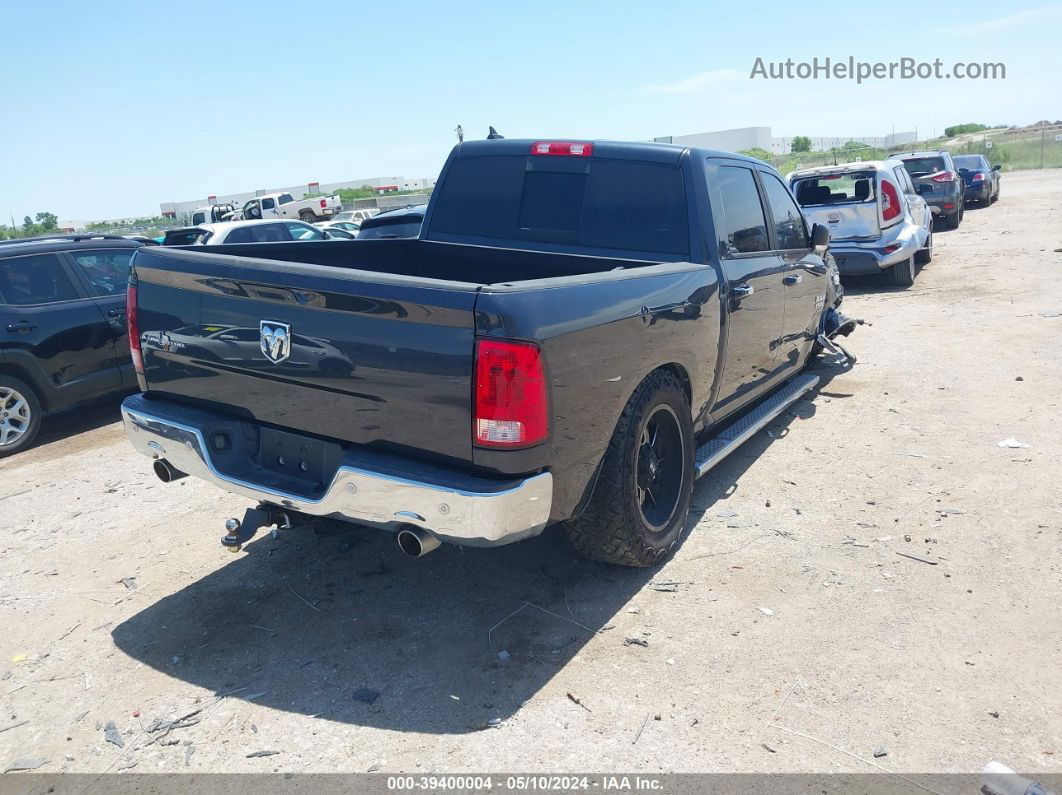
[0,236,142,459]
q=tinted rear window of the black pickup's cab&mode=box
[431,156,689,255]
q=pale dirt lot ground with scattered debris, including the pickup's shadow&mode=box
[0,171,1062,775]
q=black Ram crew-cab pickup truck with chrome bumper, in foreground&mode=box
[123,139,852,566]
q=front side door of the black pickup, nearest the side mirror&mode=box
[759,169,826,368]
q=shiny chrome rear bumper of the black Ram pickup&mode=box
[122,395,553,547]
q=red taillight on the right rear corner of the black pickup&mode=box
[473,340,549,448]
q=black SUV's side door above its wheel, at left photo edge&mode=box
[0,254,122,405]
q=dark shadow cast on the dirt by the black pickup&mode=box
[112,356,842,733]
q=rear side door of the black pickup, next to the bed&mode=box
[706,159,785,413]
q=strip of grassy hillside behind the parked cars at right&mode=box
[764,124,1062,174]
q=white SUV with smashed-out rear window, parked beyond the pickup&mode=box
[787,160,932,287]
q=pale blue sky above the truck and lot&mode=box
[0,0,1062,221]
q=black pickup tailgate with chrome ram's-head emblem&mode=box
[133,243,477,461]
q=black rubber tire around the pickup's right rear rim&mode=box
[566,370,695,568]
